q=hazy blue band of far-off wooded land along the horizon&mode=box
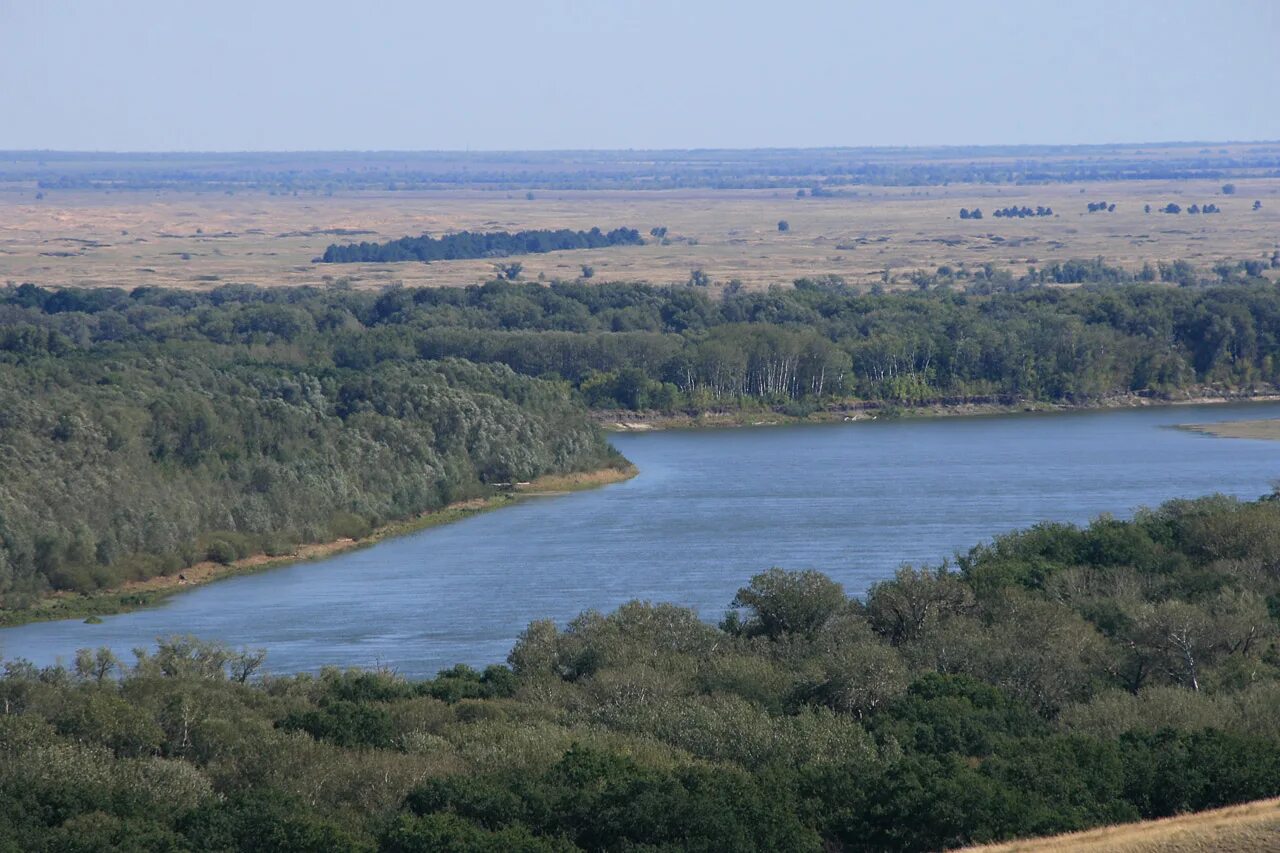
[10,145,1280,196]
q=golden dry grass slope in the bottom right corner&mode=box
[966,799,1280,853]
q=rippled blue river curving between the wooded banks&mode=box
[0,403,1280,675]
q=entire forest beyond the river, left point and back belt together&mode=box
[0,261,1280,611]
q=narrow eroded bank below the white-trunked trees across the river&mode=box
[591,387,1280,437]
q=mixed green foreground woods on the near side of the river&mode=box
[0,497,1280,853]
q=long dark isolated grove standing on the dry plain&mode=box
[320,228,644,264]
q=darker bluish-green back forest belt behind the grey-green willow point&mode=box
[0,257,1280,412]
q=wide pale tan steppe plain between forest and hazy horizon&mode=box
[0,178,1280,288]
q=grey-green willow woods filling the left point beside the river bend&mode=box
[0,285,620,604]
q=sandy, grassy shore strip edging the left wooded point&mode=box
[0,465,639,628]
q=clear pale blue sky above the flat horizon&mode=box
[0,0,1280,151]
